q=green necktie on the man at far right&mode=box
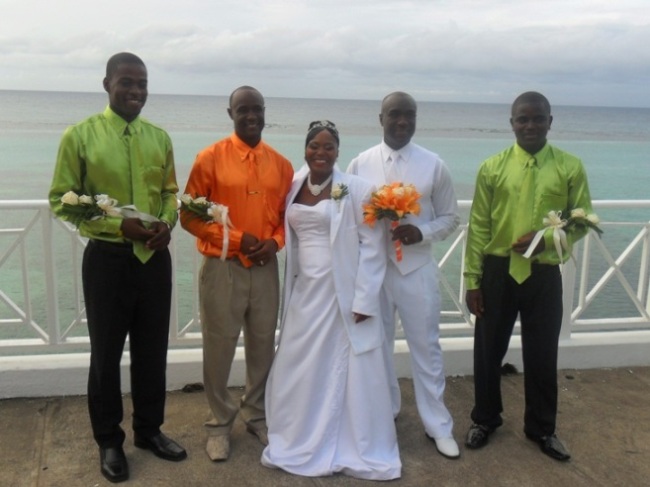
[509,157,537,284]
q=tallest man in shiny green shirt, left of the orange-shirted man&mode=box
[49,53,187,482]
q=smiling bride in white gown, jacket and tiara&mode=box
[262,121,401,480]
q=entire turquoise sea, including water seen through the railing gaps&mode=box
[0,90,650,337]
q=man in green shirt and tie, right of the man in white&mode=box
[464,92,591,461]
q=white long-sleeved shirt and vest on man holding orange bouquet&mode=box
[347,142,460,275]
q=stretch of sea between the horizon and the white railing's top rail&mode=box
[0,90,650,199]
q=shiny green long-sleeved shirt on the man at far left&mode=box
[49,107,178,264]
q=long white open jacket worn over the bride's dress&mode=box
[280,169,386,354]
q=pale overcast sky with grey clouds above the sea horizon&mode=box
[0,0,650,107]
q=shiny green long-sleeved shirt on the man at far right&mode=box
[464,143,592,290]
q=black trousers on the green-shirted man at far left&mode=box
[82,240,172,447]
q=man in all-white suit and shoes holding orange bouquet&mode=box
[348,92,460,458]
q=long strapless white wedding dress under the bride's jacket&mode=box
[262,200,401,480]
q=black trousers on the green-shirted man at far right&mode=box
[472,256,562,437]
